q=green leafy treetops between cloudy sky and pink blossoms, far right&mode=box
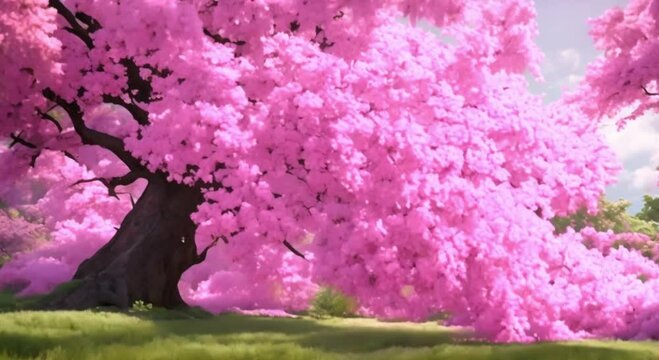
[552,196,659,238]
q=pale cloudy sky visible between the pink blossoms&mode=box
[531,0,659,213]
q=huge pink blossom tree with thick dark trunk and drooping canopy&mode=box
[0,0,659,341]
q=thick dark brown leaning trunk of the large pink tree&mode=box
[46,177,202,309]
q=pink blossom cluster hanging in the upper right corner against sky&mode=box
[577,0,659,126]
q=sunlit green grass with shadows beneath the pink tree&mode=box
[0,310,659,360]
